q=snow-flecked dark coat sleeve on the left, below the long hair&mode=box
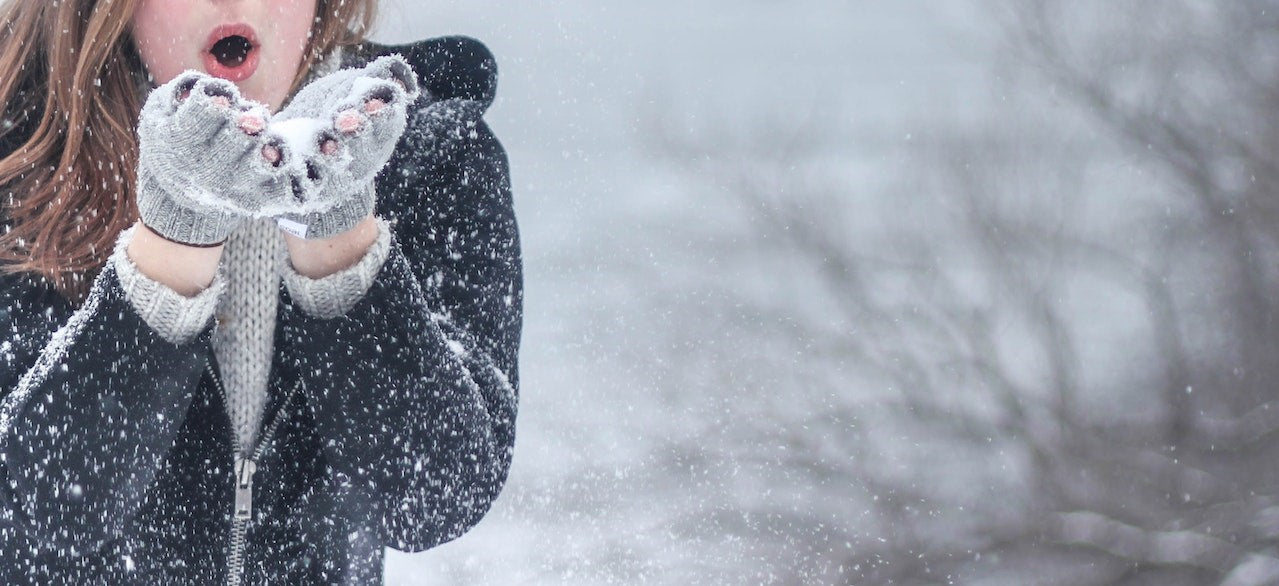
[0,246,211,555]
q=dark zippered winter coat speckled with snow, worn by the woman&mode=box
[0,37,522,585]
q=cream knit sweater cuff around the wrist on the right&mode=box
[283,216,391,320]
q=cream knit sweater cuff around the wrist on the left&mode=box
[110,226,226,344]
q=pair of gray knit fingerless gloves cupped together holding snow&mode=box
[138,55,418,246]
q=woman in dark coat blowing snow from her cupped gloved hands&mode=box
[0,0,522,583]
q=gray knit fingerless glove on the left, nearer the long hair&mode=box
[138,72,293,246]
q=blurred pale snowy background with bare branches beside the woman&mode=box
[375,0,1279,586]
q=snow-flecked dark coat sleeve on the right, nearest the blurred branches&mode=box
[284,106,523,550]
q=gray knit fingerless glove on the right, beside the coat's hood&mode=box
[267,55,418,238]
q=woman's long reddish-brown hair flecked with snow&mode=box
[0,0,377,301]
